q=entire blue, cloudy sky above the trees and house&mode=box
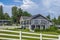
[0,0,60,18]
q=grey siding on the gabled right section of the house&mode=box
[31,16,50,29]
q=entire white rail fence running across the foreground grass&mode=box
[0,30,60,40]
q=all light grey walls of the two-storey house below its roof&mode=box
[21,16,52,30]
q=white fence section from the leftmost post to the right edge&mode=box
[20,32,60,40]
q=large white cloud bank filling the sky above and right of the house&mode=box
[21,0,60,17]
